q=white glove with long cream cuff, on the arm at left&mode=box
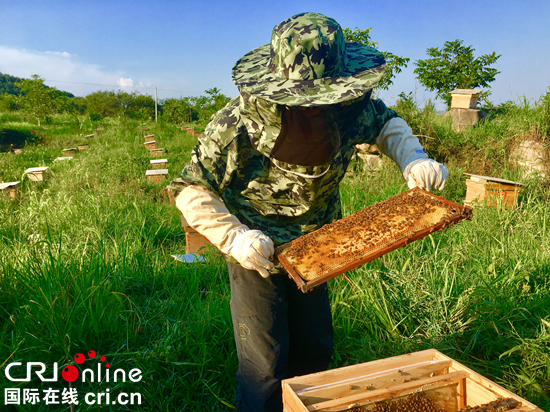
[176,185,275,278]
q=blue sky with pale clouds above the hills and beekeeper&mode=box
[0,0,550,109]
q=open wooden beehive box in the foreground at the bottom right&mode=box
[282,349,543,412]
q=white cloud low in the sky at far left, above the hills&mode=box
[0,45,144,96]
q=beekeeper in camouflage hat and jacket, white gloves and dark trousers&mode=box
[171,13,447,412]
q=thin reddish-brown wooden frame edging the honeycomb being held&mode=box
[275,189,471,293]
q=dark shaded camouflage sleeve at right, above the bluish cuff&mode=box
[352,99,399,144]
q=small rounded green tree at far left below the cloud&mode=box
[15,74,56,126]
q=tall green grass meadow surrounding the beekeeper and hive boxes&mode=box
[0,95,550,411]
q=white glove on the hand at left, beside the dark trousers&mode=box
[222,225,275,278]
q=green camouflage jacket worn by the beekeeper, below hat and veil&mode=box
[171,94,397,246]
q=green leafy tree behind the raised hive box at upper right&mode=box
[414,39,501,108]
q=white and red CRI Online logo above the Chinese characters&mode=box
[5,350,142,382]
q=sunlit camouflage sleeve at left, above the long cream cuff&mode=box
[170,98,243,197]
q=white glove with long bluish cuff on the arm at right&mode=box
[376,117,449,191]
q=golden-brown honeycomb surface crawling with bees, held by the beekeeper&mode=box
[276,188,472,281]
